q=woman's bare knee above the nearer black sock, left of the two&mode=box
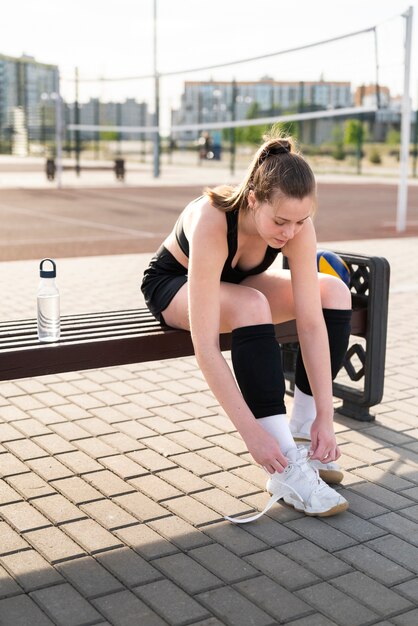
[222,287,272,330]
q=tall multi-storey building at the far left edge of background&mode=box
[0,55,59,156]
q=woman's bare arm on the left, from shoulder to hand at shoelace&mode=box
[188,204,287,472]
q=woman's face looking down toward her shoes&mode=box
[249,191,314,248]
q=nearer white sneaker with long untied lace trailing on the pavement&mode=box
[226,447,348,524]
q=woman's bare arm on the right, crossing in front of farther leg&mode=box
[286,219,339,460]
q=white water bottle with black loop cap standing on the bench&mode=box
[37,259,61,342]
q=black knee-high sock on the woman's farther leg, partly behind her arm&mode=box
[295,309,351,396]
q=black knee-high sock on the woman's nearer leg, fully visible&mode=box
[231,324,286,418]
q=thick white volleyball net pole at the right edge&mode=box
[396,7,414,233]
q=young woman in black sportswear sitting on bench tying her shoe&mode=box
[142,137,351,522]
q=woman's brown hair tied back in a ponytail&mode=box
[205,135,316,212]
